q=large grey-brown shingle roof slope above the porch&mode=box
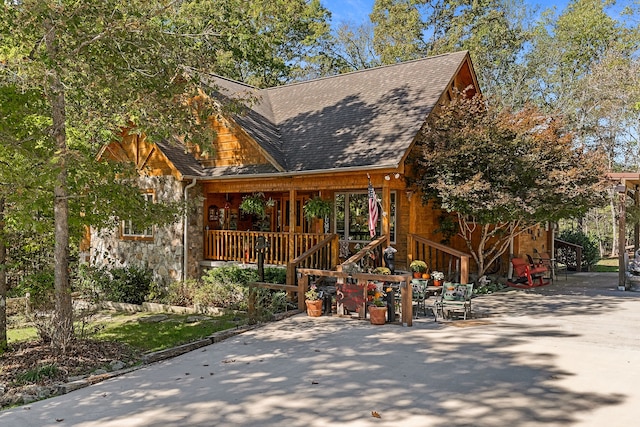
[182,52,467,175]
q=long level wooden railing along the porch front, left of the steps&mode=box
[204,230,330,265]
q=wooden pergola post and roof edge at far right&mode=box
[608,172,640,290]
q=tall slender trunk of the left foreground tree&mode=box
[45,20,73,351]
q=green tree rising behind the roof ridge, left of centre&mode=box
[198,0,333,87]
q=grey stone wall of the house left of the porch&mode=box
[90,176,203,285]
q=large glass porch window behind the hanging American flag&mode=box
[335,192,396,242]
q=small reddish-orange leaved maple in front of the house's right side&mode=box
[416,96,606,277]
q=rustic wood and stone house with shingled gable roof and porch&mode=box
[91,52,549,290]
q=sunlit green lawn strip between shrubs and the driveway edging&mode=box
[7,311,247,352]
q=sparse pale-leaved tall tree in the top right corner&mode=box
[527,0,640,254]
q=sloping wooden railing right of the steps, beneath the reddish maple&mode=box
[407,234,471,284]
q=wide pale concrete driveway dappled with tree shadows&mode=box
[0,273,640,427]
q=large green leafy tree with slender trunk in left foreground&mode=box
[0,0,330,352]
